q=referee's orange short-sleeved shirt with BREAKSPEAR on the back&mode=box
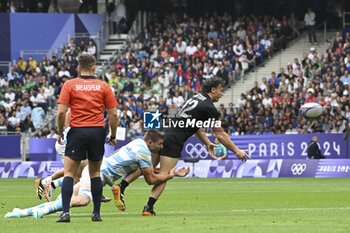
[57,76,118,127]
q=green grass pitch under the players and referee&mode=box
[0,178,350,233]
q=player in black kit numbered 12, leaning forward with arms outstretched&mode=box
[114,77,251,216]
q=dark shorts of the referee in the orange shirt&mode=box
[65,127,106,162]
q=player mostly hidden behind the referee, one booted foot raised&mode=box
[35,109,111,202]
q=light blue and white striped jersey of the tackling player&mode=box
[101,139,153,186]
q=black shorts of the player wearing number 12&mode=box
[159,133,184,159]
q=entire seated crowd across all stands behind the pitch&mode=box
[0,13,350,137]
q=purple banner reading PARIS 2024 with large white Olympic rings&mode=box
[181,134,349,159]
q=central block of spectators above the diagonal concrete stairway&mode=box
[101,13,299,136]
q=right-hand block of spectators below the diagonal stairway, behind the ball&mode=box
[220,32,350,135]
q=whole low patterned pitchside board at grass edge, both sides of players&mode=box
[0,159,350,178]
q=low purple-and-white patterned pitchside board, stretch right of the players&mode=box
[177,159,350,178]
